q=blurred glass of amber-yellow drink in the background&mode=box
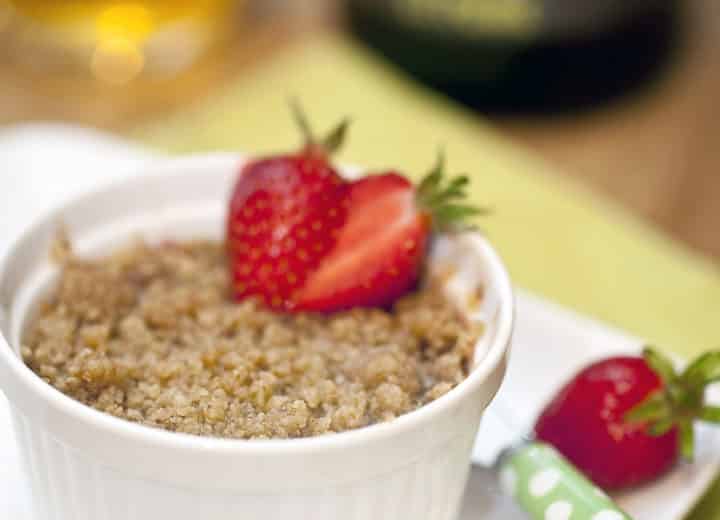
[0,0,242,84]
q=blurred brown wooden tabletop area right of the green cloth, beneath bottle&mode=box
[498,0,720,260]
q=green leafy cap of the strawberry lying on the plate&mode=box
[625,347,720,460]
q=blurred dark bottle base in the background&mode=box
[346,0,684,114]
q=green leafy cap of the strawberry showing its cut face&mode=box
[417,149,488,231]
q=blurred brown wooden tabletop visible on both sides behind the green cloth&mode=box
[0,0,720,260]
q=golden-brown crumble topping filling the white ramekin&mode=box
[22,241,481,439]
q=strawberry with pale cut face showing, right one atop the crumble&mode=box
[296,152,479,312]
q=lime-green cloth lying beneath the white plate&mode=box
[132,36,720,519]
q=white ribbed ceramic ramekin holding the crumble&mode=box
[0,155,513,520]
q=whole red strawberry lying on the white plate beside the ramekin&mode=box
[535,348,720,490]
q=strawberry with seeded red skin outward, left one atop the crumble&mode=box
[226,105,348,310]
